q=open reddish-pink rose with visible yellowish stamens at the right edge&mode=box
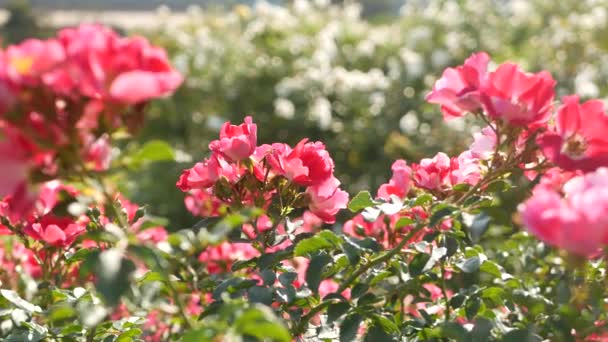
[538,95,608,171]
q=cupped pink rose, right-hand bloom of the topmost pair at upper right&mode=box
[482,63,555,126]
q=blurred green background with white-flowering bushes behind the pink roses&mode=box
[0,0,608,229]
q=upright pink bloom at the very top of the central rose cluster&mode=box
[209,116,257,161]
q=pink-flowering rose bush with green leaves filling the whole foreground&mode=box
[0,25,608,341]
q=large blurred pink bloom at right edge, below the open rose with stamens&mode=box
[519,168,608,256]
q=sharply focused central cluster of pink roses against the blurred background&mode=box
[177,117,348,223]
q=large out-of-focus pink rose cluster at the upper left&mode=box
[0,25,182,222]
